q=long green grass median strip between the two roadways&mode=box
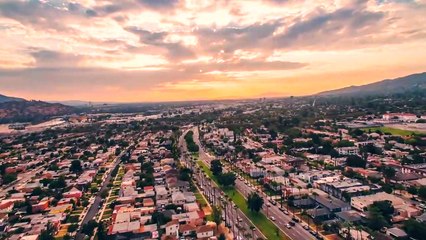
[197,160,290,240]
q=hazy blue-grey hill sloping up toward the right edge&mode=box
[317,72,426,97]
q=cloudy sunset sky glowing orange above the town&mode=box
[0,0,426,102]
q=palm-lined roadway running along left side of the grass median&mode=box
[179,130,266,240]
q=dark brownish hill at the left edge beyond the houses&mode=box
[0,95,75,123]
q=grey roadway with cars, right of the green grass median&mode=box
[192,127,316,240]
